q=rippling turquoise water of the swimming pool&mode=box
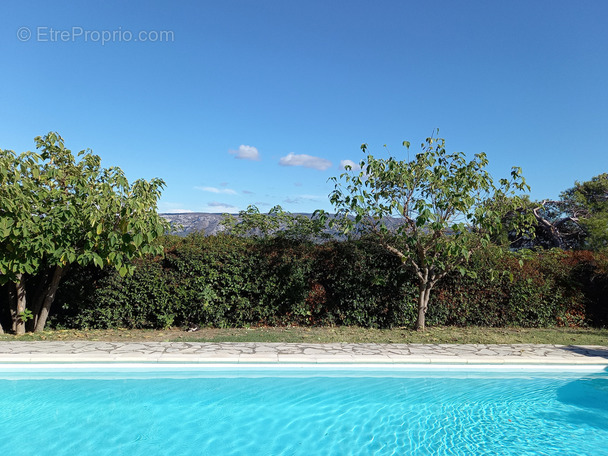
[0,369,608,456]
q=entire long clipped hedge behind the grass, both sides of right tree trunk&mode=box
[49,235,608,329]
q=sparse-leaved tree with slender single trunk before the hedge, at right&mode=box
[330,137,529,330]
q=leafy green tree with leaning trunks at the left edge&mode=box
[0,133,167,334]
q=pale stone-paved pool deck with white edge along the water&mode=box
[0,341,608,366]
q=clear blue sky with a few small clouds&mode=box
[0,0,608,212]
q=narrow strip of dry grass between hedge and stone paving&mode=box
[0,326,608,345]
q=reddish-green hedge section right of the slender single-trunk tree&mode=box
[429,251,589,327]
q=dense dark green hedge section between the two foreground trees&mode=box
[52,234,418,328]
